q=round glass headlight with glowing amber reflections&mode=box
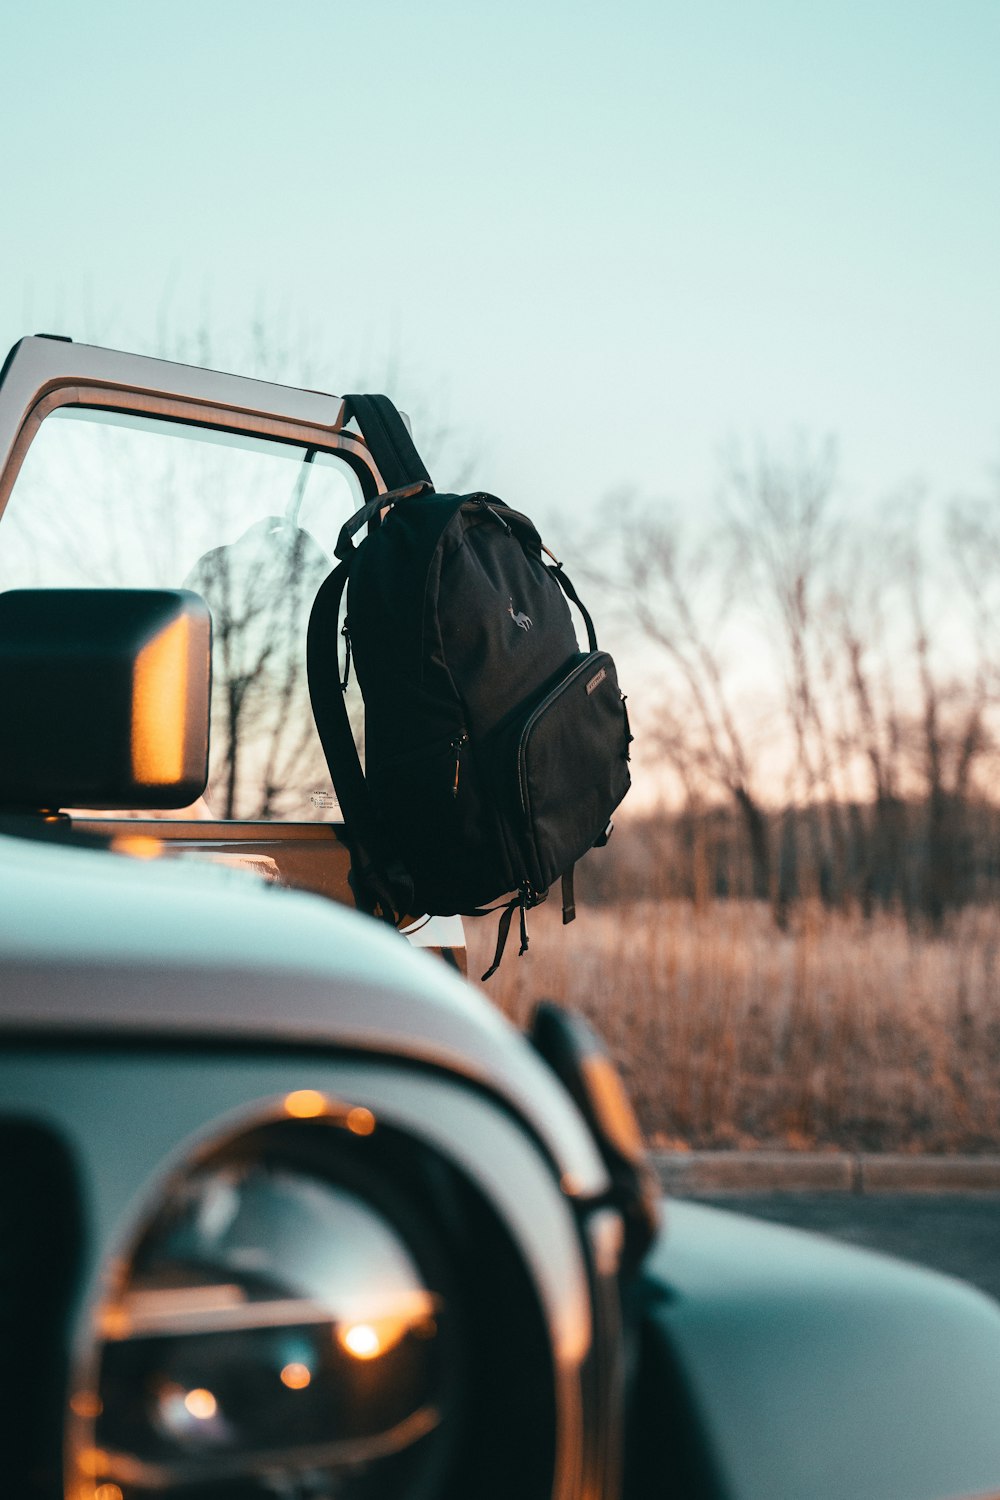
[76,1127,456,1500]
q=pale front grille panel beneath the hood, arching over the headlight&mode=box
[0,1037,591,1365]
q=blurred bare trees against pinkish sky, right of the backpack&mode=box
[591,443,1000,924]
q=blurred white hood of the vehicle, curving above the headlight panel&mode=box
[0,830,607,1197]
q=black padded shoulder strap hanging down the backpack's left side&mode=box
[306,561,411,921]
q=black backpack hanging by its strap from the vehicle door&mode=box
[307,396,631,978]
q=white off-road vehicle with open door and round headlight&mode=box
[0,338,1000,1500]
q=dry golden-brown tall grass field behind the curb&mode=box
[468,899,1000,1152]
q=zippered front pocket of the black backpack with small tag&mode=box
[516,651,631,891]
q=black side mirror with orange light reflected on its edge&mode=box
[0,588,211,810]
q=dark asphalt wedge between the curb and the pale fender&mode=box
[685,1193,1000,1299]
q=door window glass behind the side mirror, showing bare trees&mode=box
[0,407,363,821]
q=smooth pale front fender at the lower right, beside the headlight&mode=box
[643,1202,1000,1500]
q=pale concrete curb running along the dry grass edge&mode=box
[651,1151,1000,1197]
